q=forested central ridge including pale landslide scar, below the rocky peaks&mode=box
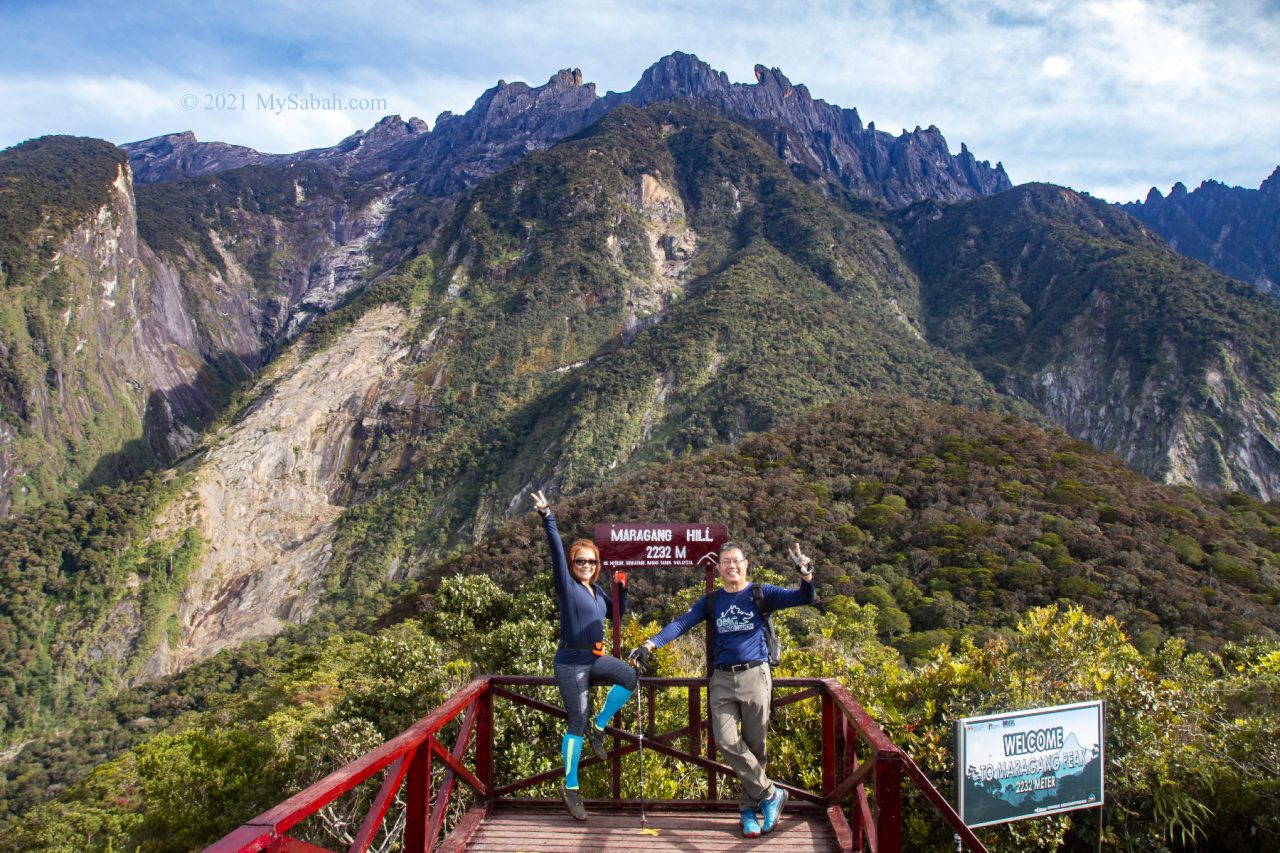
[154,99,1016,663]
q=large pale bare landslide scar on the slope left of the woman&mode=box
[140,306,410,679]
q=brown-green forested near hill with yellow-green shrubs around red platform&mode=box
[4,396,1280,850]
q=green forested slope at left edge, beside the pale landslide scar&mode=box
[0,475,204,743]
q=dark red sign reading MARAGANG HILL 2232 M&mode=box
[595,524,728,571]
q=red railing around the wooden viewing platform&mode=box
[206,675,986,853]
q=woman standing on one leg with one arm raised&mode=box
[532,492,636,821]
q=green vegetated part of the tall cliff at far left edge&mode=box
[0,136,170,514]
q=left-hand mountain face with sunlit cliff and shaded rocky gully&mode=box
[0,137,404,514]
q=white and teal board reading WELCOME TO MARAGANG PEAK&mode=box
[955,702,1103,826]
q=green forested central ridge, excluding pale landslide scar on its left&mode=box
[314,108,1011,607]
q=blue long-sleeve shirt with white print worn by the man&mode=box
[649,578,814,666]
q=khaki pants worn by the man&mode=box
[708,663,773,808]
